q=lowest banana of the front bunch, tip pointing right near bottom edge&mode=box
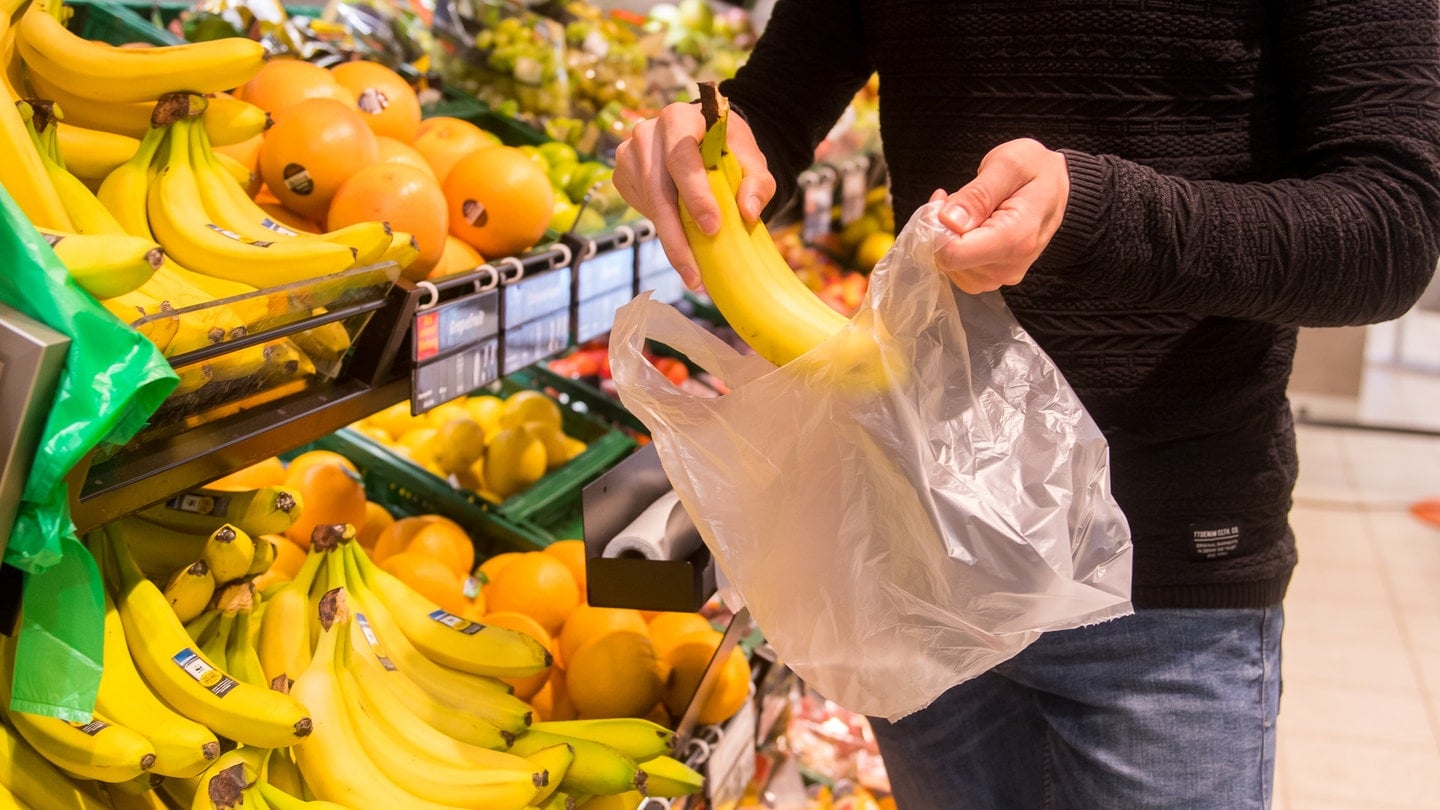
[336,631,547,810]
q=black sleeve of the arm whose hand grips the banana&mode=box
[720,0,873,212]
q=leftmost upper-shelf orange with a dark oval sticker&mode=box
[261,98,380,221]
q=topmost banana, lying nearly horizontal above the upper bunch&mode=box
[16,0,265,102]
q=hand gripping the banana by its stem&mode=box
[615,104,775,290]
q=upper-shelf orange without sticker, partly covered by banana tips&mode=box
[325,163,448,281]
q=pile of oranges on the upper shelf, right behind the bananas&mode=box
[219,58,554,281]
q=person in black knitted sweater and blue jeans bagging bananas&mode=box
[615,0,1440,810]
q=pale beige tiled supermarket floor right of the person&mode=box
[1274,360,1440,810]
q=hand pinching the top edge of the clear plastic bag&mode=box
[930,138,1070,294]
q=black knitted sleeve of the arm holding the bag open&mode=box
[1040,1,1440,326]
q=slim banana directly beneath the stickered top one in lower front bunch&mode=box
[340,543,533,706]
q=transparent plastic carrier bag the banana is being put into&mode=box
[611,203,1130,719]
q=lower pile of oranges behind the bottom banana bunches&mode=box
[212,450,750,726]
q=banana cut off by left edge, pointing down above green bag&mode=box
[0,0,75,231]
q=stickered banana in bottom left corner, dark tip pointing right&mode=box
[0,644,156,783]
